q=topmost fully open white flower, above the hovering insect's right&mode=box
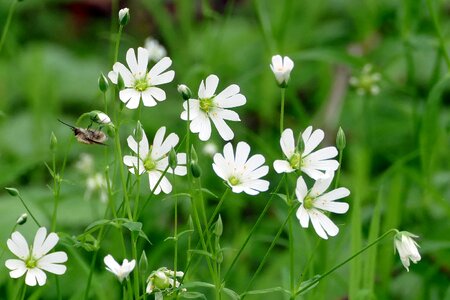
[108,47,175,109]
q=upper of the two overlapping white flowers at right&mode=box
[273,126,339,180]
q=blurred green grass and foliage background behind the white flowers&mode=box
[0,0,450,299]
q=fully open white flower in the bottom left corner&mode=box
[5,227,67,286]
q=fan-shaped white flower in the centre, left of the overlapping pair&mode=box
[213,142,269,195]
